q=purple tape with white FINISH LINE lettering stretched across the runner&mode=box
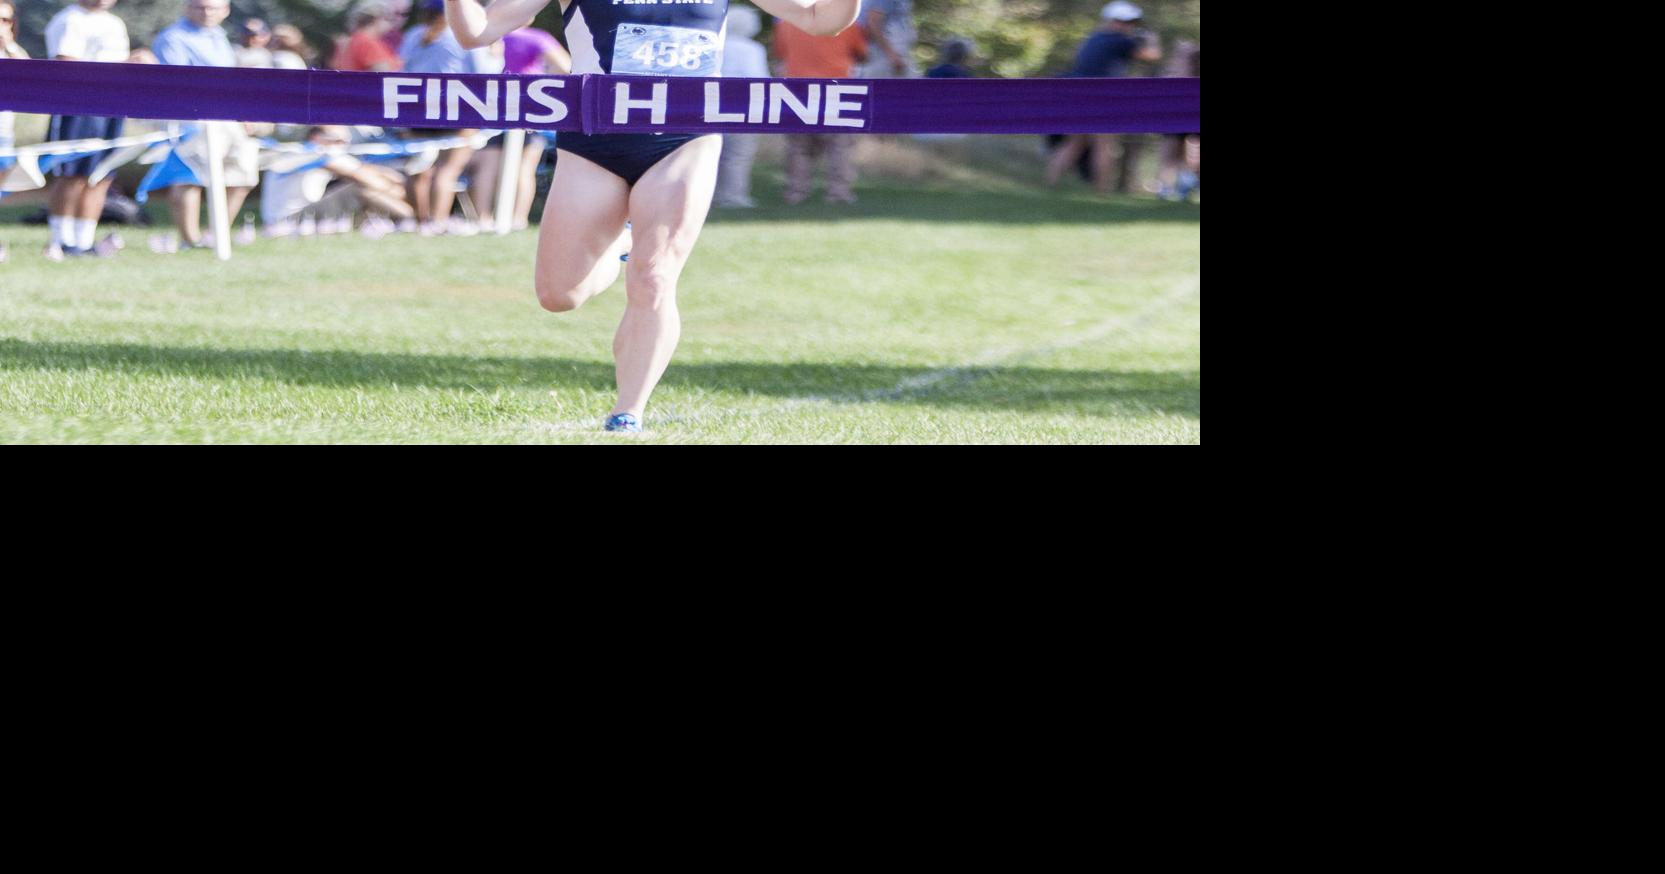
[0,60,1202,133]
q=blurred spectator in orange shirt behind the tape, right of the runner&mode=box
[774,15,867,205]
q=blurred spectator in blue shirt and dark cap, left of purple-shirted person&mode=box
[400,0,503,235]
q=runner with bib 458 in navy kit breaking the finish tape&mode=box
[446,0,861,433]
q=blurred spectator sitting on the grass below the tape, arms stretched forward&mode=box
[260,125,415,236]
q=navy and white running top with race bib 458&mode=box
[564,0,728,77]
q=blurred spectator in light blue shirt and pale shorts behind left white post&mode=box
[150,0,260,250]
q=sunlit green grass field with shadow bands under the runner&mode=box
[0,142,1202,444]
